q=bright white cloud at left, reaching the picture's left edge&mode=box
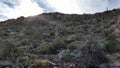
[0,0,43,21]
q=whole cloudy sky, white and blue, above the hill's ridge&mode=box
[0,0,120,21]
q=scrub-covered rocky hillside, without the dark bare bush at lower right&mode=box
[0,9,120,68]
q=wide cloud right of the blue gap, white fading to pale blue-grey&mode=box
[48,0,109,14]
